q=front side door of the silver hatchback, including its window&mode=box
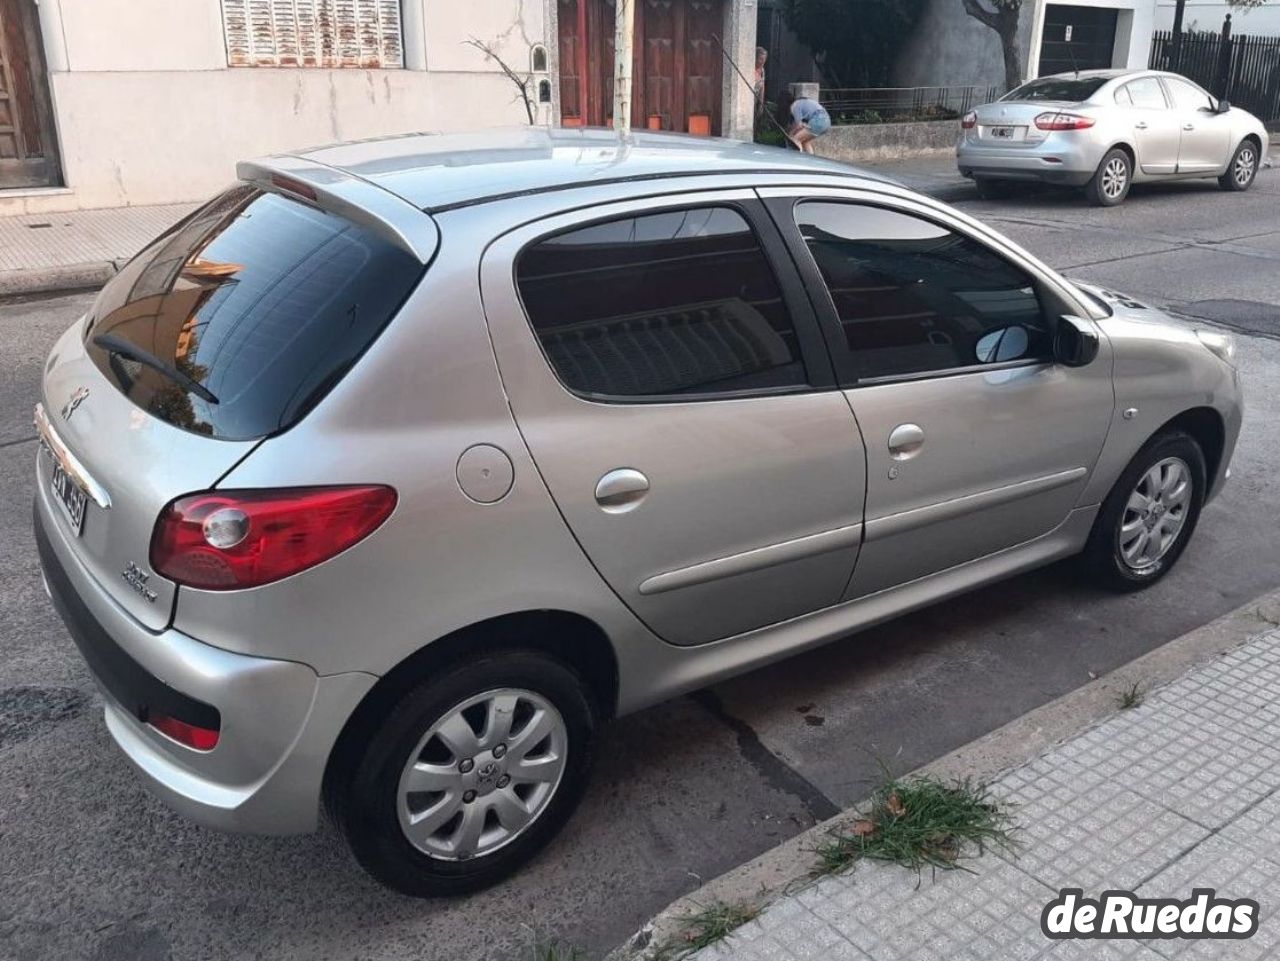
[762,189,1114,599]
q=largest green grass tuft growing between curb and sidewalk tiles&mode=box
[815,777,1014,874]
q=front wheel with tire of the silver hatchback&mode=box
[1080,430,1207,591]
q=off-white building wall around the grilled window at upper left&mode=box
[0,0,556,215]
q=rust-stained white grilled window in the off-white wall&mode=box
[223,0,404,68]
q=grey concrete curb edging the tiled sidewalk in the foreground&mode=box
[605,590,1280,961]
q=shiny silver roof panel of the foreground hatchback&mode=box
[286,127,893,212]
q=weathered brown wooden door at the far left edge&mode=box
[0,0,59,188]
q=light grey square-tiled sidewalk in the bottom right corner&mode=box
[694,631,1280,961]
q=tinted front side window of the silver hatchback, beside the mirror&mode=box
[796,202,1052,379]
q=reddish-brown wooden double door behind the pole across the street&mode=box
[557,0,724,134]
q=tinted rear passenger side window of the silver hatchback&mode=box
[516,207,808,397]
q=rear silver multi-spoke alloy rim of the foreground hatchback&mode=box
[397,688,568,861]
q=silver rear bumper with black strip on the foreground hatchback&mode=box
[35,491,378,834]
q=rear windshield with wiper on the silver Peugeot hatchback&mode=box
[86,184,424,440]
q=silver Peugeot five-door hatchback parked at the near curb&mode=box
[35,129,1242,894]
